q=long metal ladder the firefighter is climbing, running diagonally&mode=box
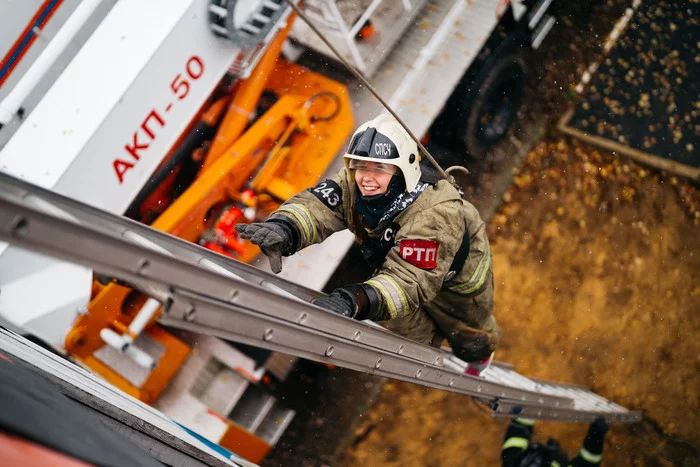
[0,173,642,423]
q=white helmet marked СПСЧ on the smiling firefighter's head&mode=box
[344,114,421,193]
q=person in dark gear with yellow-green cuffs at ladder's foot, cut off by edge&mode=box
[501,417,609,467]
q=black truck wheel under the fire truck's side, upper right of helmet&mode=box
[456,53,526,157]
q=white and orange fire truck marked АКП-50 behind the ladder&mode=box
[0,0,555,462]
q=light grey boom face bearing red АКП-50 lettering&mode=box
[55,0,243,213]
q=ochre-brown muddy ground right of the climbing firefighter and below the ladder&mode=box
[342,139,700,466]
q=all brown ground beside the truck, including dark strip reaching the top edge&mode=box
[264,0,700,466]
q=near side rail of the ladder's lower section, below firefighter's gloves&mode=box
[161,291,572,407]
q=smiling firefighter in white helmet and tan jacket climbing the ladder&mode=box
[236,115,500,376]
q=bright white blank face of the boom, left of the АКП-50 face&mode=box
[0,0,190,188]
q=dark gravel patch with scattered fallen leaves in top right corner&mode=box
[569,1,700,167]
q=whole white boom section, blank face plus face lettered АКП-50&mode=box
[0,0,237,212]
